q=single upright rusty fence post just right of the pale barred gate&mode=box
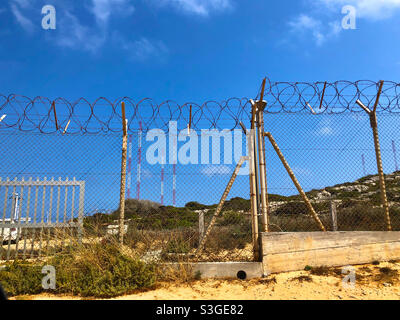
[119,102,128,247]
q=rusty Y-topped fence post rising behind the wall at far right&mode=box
[356,81,392,231]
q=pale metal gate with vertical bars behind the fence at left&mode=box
[0,177,85,261]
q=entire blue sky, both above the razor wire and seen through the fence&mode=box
[0,0,400,216]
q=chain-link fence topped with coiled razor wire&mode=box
[0,83,400,261]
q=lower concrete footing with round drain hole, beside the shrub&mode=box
[164,262,264,279]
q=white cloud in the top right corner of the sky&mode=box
[316,0,400,20]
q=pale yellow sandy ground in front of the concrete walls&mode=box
[10,262,400,300]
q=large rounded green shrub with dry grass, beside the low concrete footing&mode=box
[54,245,155,298]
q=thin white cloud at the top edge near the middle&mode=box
[157,0,232,16]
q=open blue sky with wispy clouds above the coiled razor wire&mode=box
[0,0,400,102]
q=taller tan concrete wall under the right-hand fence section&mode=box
[262,231,400,275]
